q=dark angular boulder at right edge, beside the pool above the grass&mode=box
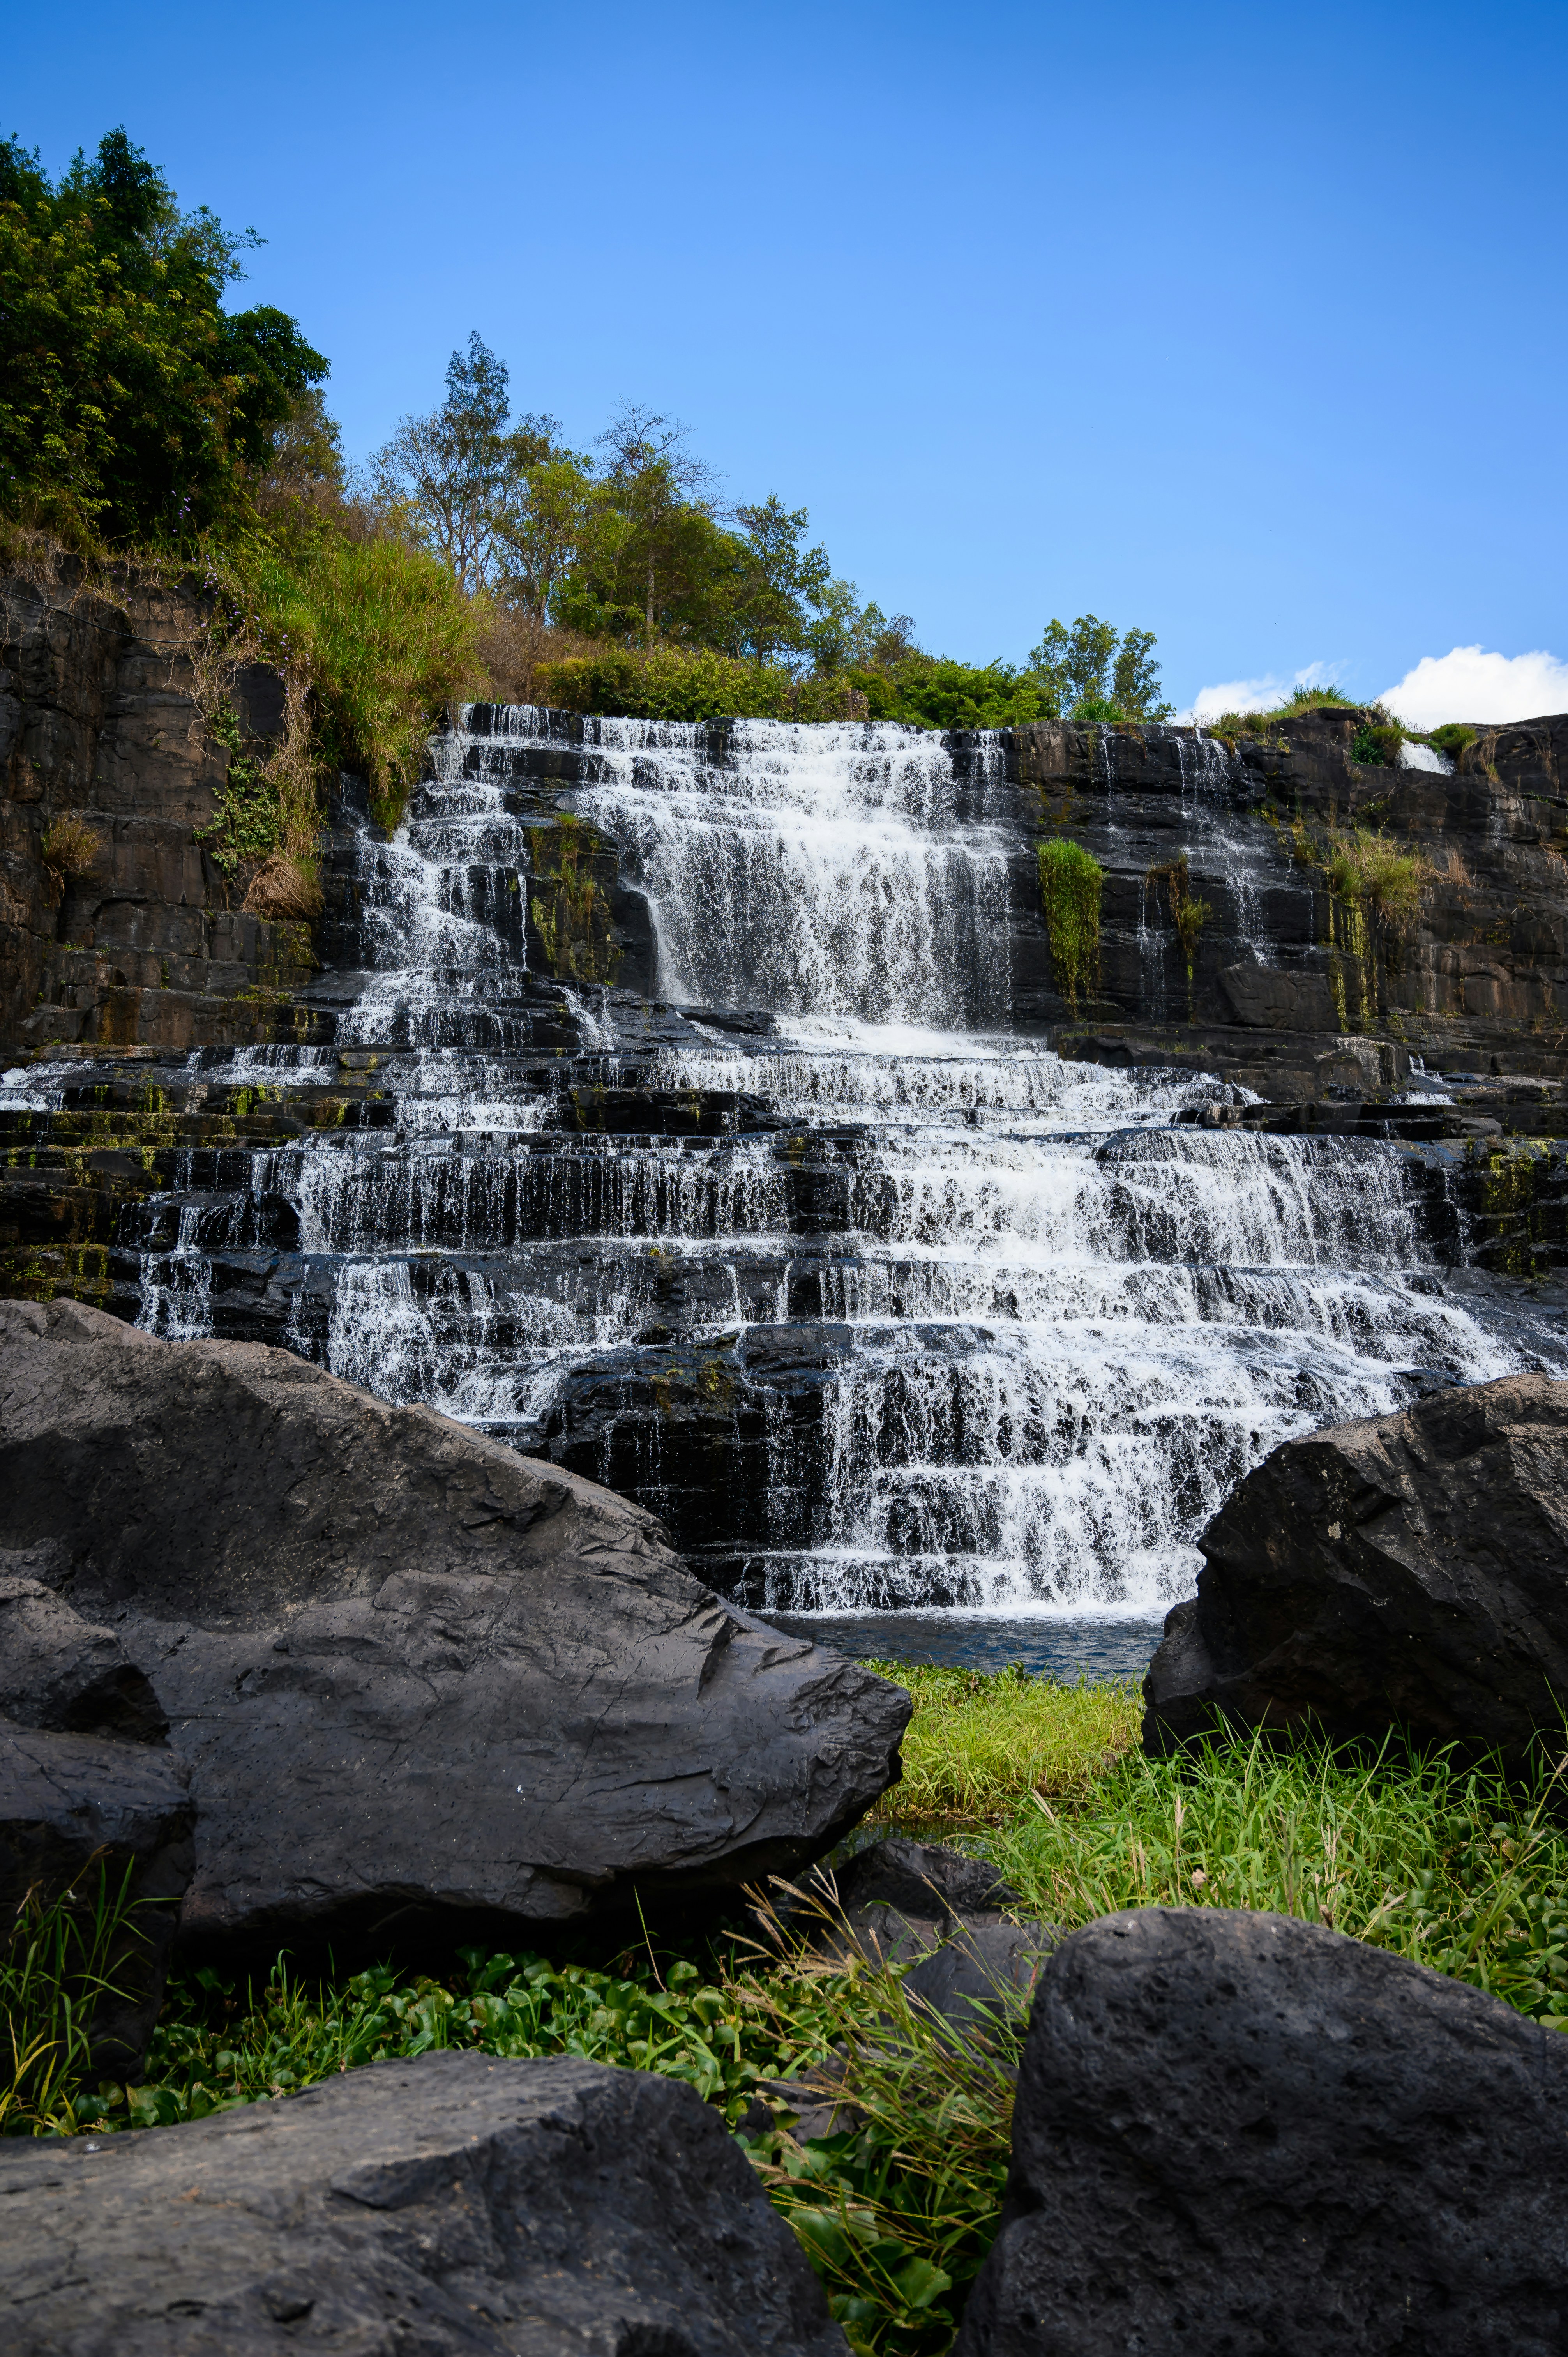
[1144,1374,1568,1758]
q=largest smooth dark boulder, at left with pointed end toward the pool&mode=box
[0,1301,910,1940]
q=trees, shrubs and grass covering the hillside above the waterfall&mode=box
[0,130,1167,872]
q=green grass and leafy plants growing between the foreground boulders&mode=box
[0,1669,1568,2357]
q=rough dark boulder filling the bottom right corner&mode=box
[957,1907,1568,2357]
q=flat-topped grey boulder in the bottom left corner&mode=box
[0,2053,844,2357]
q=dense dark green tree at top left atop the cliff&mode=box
[0,130,328,544]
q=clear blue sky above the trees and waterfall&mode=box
[2,0,1568,719]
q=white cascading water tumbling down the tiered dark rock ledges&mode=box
[122,707,1556,1650]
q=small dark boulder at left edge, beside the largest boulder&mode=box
[0,1718,196,2079]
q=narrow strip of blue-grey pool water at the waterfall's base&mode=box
[757,1612,1165,1685]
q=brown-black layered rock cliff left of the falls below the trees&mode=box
[0,558,330,1060]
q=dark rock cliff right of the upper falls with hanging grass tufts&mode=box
[990,707,1568,1079]
